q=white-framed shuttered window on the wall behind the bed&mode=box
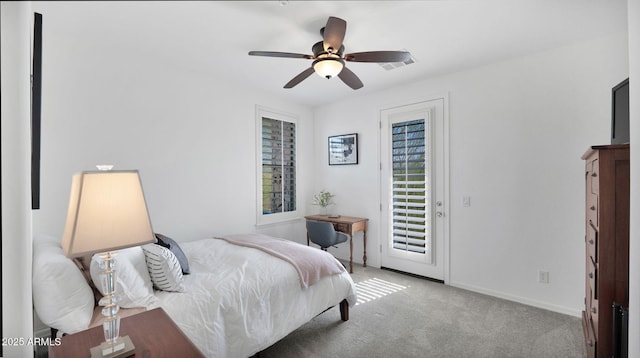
[257,107,297,224]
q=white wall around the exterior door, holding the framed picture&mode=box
[315,34,628,316]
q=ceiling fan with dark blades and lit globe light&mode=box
[249,16,411,90]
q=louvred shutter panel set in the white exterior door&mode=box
[391,119,430,254]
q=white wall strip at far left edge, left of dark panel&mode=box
[0,1,33,357]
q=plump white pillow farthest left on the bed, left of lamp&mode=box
[31,236,94,333]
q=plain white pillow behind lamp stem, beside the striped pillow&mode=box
[90,246,156,308]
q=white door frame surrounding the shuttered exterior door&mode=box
[377,92,452,284]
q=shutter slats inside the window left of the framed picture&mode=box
[262,117,296,214]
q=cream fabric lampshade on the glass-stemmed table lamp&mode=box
[62,170,155,257]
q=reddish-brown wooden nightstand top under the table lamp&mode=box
[49,308,204,358]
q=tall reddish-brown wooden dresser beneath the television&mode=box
[582,144,629,358]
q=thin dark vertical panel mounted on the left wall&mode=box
[31,13,42,209]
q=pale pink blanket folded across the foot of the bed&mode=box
[218,234,345,288]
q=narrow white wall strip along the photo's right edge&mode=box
[628,0,640,357]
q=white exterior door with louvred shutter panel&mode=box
[380,97,448,280]
